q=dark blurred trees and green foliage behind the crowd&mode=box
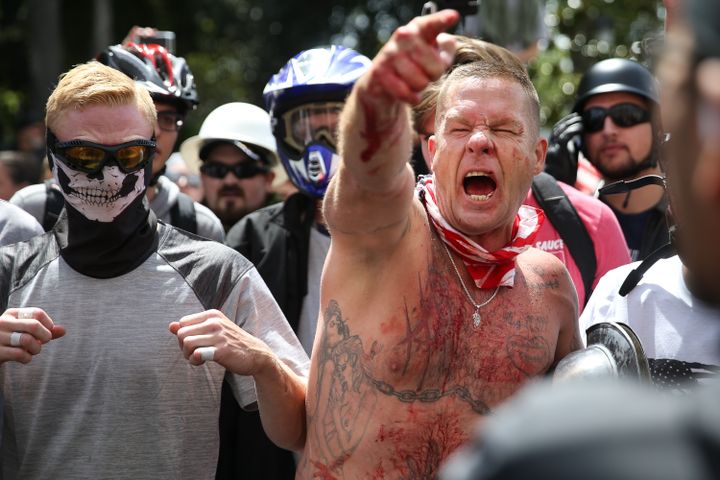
[0,0,664,148]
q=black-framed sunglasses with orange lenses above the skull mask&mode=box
[47,130,156,173]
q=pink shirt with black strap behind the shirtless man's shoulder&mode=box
[525,182,630,312]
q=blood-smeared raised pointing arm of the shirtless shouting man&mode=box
[323,10,458,248]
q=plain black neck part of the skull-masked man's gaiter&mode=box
[55,195,158,278]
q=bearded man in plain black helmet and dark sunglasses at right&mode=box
[546,58,668,260]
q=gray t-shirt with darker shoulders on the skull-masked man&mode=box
[0,225,309,480]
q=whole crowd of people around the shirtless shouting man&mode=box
[0,0,720,480]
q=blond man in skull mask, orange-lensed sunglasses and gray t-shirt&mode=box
[0,62,308,479]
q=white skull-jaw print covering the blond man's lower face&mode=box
[52,156,152,223]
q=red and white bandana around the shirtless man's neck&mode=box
[416,175,545,288]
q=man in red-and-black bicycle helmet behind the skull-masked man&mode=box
[11,36,225,242]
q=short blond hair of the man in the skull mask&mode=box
[45,60,157,130]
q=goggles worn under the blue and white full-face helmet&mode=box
[282,102,344,154]
